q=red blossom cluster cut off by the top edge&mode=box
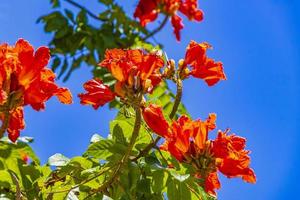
[134,0,203,41]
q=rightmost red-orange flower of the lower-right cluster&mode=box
[212,131,256,183]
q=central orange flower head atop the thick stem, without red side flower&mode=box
[99,49,164,97]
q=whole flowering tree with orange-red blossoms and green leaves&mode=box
[0,0,256,200]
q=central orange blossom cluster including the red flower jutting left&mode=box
[79,49,164,109]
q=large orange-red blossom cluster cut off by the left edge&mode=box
[0,39,72,142]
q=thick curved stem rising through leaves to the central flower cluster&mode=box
[85,106,142,199]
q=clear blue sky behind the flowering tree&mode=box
[0,0,300,200]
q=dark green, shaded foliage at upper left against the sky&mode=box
[37,0,149,81]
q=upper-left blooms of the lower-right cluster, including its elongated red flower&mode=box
[143,104,216,161]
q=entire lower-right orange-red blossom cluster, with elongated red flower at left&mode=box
[143,104,256,195]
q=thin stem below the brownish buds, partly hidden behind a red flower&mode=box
[132,79,183,162]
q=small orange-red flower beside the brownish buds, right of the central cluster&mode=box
[184,41,226,86]
